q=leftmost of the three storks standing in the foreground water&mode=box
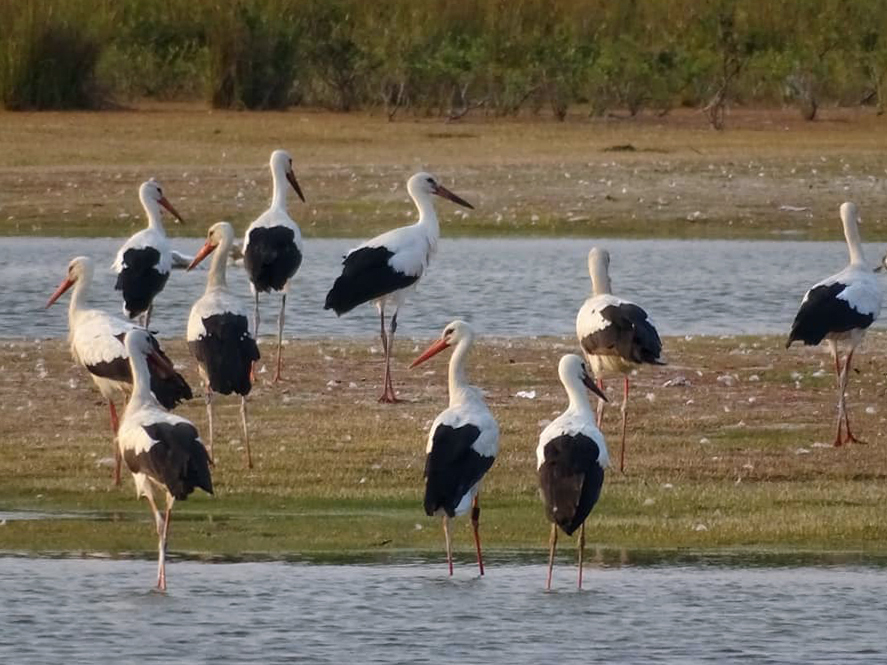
[117,329,213,591]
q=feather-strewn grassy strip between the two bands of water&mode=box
[0,332,887,561]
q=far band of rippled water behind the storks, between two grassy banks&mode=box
[0,238,882,338]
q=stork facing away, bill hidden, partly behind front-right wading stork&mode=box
[576,247,665,473]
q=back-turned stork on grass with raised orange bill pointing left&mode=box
[187,222,259,469]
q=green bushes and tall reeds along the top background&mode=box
[0,0,887,128]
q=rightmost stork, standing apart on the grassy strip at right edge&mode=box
[785,202,883,446]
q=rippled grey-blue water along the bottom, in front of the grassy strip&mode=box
[0,555,887,665]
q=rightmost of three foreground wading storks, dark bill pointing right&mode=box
[536,353,610,589]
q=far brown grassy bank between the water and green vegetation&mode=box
[0,103,887,241]
